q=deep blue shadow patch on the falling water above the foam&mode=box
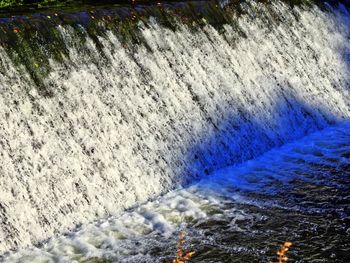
[187,94,342,185]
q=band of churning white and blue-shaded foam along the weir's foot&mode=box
[5,123,350,263]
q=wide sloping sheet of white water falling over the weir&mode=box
[0,1,350,260]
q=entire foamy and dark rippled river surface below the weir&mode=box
[8,123,350,262]
